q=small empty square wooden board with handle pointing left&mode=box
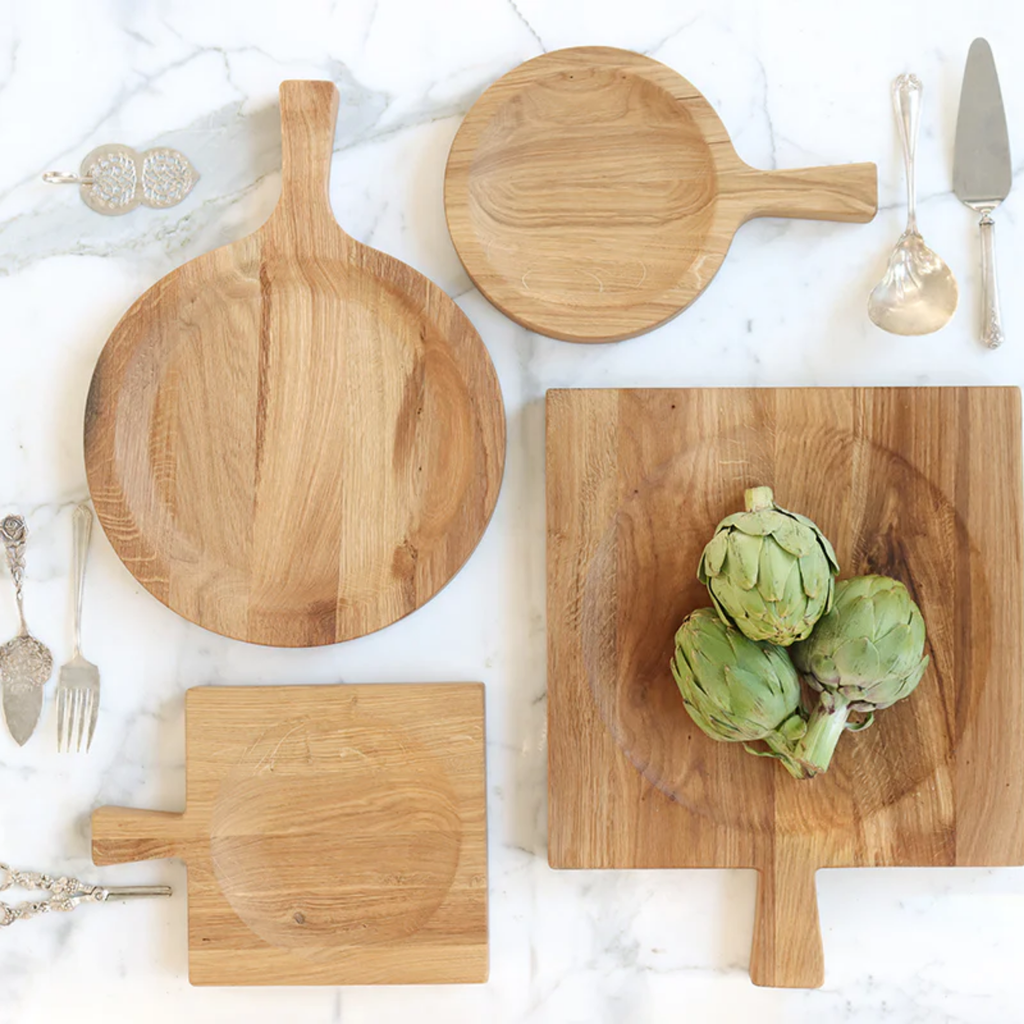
[92,683,487,985]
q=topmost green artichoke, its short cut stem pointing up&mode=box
[697,487,839,647]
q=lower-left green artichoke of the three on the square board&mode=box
[672,608,807,778]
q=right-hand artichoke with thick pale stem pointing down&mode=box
[792,575,929,772]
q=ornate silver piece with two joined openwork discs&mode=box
[43,144,199,217]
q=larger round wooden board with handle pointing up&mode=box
[85,82,505,647]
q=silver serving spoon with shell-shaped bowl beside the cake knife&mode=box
[867,75,958,334]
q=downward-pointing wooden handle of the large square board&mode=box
[751,836,825,988]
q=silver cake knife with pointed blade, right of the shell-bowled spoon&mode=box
[953,39,1013,348]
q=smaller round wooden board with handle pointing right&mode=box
[444,46,878,342]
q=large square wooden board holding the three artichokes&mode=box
[547,387,1024,987]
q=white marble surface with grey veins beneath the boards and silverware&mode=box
[0,0,1024,1024]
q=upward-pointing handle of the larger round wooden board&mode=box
[271,82,338,235]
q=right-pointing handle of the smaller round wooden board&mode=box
[723,164,879,224]
